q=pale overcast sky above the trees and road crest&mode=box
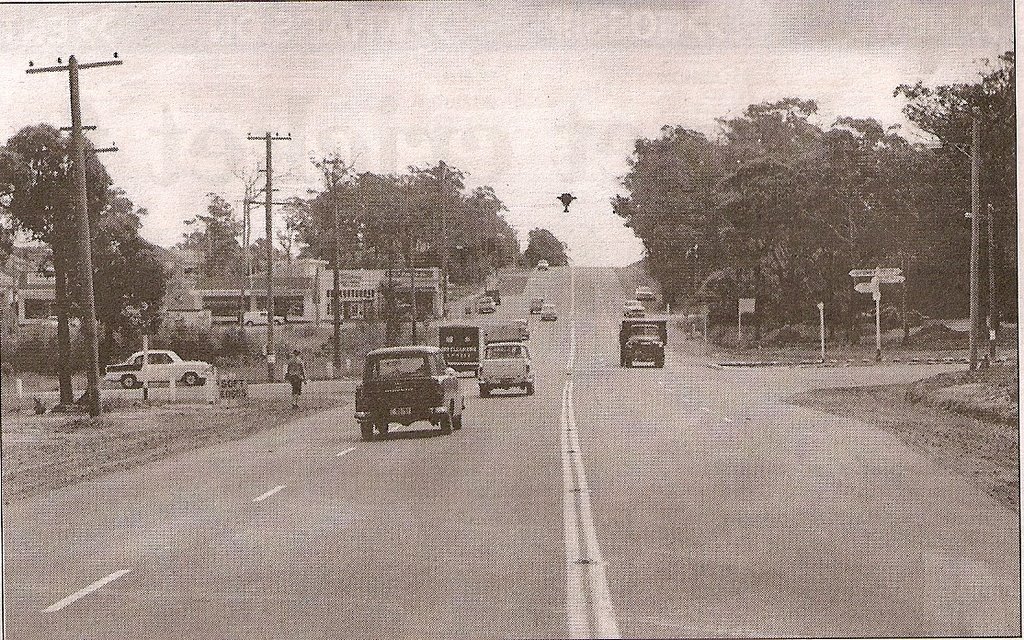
[0,0,1014,265]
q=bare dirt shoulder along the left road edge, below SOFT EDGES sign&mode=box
[0,390,351,504]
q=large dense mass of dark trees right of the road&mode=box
[611,51,1017,341]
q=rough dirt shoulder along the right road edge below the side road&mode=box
[793,367,1020,513]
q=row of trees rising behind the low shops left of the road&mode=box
[179,158,520,283]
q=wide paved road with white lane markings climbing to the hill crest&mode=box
[3,268,1020,638]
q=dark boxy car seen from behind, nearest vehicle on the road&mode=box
[355,346,466,440]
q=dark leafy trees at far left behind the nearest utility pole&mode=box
[0,124,167,403]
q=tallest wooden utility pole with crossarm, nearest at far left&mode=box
[26,53,122,417]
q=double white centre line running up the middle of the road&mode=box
[559,266,620,638]
